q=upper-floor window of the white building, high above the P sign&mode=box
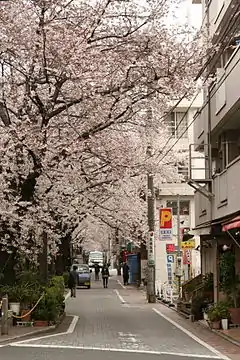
[168,112,188,139]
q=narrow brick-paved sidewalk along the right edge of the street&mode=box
[116,285,240,360]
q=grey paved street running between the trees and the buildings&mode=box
[0,279,235,360]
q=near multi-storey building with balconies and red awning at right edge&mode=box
[189,0,240,301]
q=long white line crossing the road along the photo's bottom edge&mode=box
[10,343,221,359]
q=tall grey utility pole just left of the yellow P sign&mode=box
[147,146,156,303]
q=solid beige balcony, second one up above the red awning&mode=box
[207,46,240,132]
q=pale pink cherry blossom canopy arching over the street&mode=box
[0,0,206,260]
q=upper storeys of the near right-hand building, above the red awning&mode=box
[194,0,240,226]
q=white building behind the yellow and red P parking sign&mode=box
[155,94,202,287]
